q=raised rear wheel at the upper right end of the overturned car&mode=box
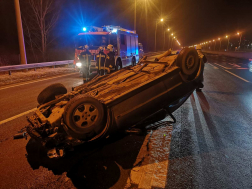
[177,48,200,79]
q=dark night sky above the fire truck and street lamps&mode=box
[0,0,252,51]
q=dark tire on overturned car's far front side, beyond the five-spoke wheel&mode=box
[37,83,67,105]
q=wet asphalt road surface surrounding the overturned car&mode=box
[0,55,252,188]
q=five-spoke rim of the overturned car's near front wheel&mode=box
[73,103,99,128]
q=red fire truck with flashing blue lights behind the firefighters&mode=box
[74,25,139,70]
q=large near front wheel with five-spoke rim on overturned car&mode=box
[63,94,106,141]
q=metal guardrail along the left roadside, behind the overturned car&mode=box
[0,60,73,75]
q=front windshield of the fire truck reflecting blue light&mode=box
[75,35,108,49]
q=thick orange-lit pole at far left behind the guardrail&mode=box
[14,0,27,64]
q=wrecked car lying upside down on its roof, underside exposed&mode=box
[17,48,207,157]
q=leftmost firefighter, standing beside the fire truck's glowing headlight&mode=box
[79,45,91,83]
